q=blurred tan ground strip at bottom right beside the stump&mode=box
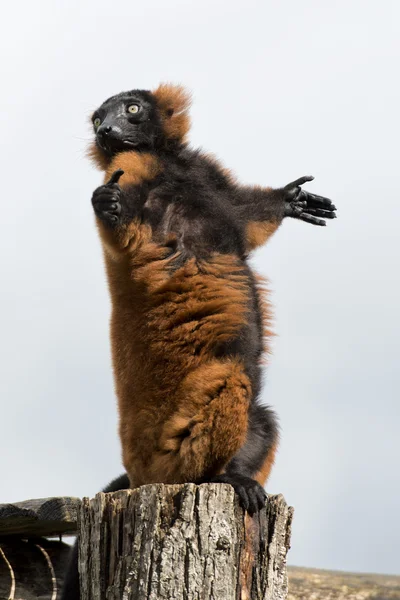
[288,567,400,600]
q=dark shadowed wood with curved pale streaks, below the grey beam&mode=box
[0,536,71,600]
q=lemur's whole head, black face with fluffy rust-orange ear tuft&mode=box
[89,84,190,169]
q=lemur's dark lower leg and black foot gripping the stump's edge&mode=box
[212,404,278,514]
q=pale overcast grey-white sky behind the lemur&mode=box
[0,0,400,573]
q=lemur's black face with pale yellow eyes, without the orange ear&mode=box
[92,90,162,156]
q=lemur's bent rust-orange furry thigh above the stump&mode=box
[141,359,251,483]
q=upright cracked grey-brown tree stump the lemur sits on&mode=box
[79,484,293,600]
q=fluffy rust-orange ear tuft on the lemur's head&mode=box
[153,83,191,142]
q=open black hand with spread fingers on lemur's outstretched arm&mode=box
[283,175,336,225]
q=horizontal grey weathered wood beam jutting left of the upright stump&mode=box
[0,497,81,536]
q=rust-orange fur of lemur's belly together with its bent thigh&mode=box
[108,246,251,486]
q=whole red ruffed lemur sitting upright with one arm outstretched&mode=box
[60,85,336,599]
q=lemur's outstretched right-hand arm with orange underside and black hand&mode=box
[233,176,336,251]
